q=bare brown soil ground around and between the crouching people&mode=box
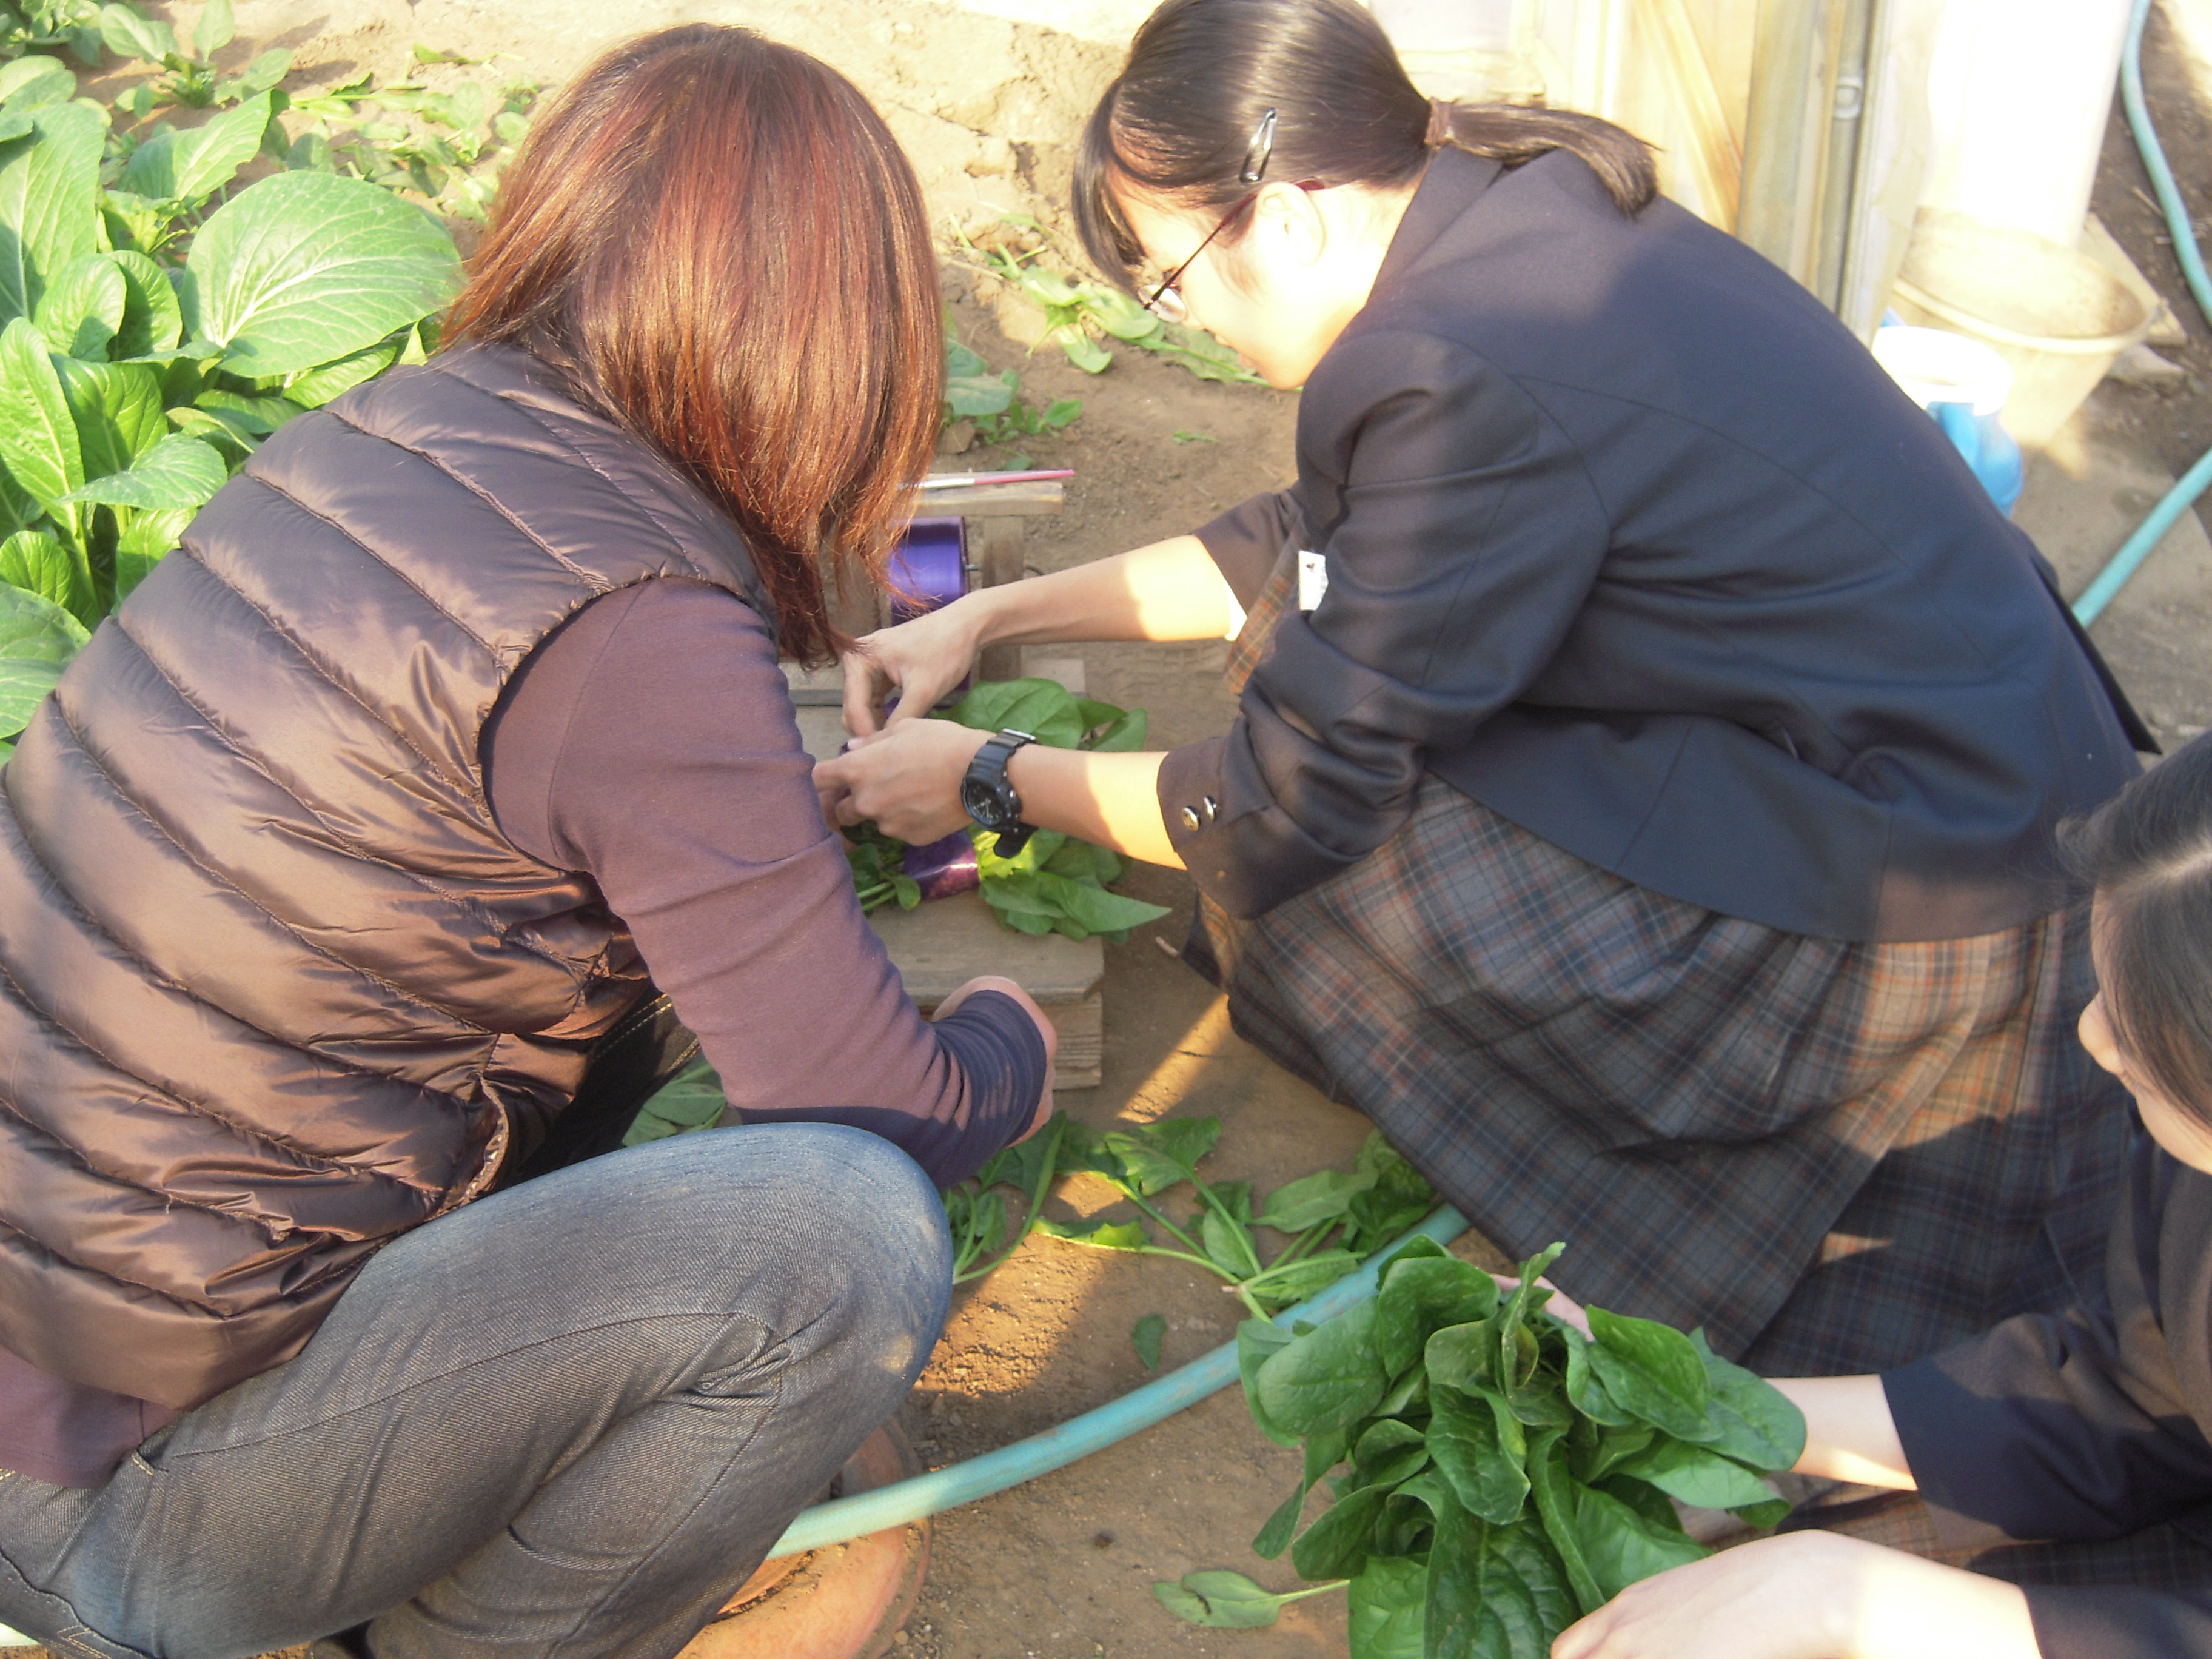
[25,0,2212,1659]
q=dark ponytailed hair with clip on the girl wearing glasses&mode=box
[1075,0,1659,286]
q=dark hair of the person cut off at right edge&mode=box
[2059,737,2212,1126]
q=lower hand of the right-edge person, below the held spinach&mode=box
[1550,1533,2039,1659]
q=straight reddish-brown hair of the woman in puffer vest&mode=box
[444,24,945,662]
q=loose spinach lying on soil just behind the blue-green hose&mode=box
[1037,1117,1436,1318]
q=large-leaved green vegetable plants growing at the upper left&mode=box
[0,27,460,757]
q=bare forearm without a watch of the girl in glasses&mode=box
[960,535,1235,646]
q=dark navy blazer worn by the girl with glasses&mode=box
[1159,150,2148,940]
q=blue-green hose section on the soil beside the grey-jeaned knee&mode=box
[768,1205,1467,1560]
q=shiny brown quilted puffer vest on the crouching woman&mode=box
[0,347,772,1407]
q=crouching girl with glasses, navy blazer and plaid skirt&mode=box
[816,0,2148,1372]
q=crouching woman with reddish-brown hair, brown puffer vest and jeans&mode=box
[0,27,1053,1659]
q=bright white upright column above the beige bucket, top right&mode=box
[1920,0,2130,248]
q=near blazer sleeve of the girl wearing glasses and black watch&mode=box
[1159,332,1610,916]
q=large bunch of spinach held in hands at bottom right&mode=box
[1155,1239,1805,1659]
